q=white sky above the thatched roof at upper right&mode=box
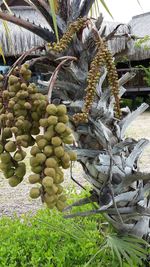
[100,0,150,22]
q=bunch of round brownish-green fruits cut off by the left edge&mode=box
[0,64,47,186]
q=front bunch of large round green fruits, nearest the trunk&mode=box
[29,104,76,211]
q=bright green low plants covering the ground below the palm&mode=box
[0,191,146,267]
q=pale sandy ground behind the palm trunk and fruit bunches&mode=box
[0,112,150,219]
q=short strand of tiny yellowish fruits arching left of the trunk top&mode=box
[47,18,87,53]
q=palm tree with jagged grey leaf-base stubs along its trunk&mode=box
[0,0,150,243]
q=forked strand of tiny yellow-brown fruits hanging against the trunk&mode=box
[73,40,121,123]
